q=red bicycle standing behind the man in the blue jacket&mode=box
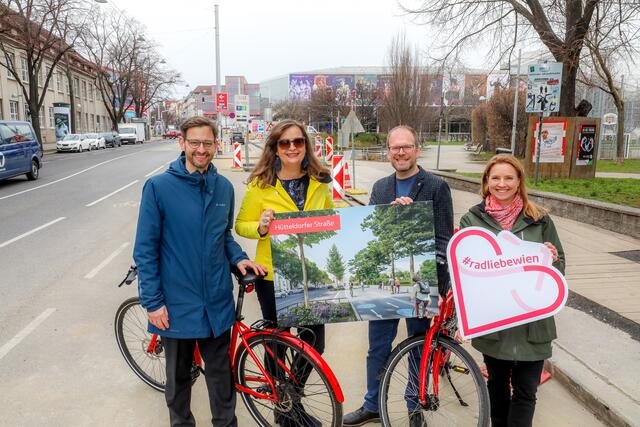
[115,266,344,426]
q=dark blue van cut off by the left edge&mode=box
[0,120,42,181]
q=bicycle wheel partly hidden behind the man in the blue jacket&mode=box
[114,297,167,391]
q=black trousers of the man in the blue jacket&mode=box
[162,331,238,427]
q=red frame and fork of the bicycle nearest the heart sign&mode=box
[419,290,454,407]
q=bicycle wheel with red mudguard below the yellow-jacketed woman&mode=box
[234,335,342,427]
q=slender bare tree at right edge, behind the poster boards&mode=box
[579,2,640,164]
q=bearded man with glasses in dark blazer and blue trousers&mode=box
[343,125,453,427]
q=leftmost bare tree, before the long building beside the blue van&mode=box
[0,0,87,146]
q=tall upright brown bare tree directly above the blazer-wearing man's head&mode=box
[381,34,429,129]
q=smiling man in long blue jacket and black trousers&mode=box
[133,117,265,426]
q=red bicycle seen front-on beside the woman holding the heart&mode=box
[379,291,489,427]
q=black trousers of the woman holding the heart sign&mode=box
[483,354,544,427]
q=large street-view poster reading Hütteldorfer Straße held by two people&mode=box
[269,202,437,327]
